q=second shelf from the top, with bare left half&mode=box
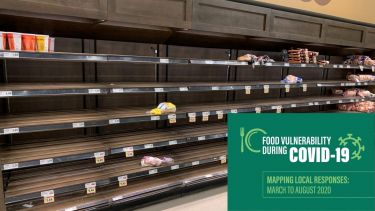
[0,80,375,98]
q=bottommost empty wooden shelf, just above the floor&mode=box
[7,164,227,211]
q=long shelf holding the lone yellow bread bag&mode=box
[0,96,375,135]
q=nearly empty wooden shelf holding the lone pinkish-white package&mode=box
[5,141,227,204]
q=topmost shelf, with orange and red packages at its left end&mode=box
[0,51,375,72]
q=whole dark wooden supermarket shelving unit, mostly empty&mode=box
[0,0,375,211]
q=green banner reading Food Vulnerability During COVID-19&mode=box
[228,114,375,211]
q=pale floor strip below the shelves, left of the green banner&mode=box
[136,185,227,211]
